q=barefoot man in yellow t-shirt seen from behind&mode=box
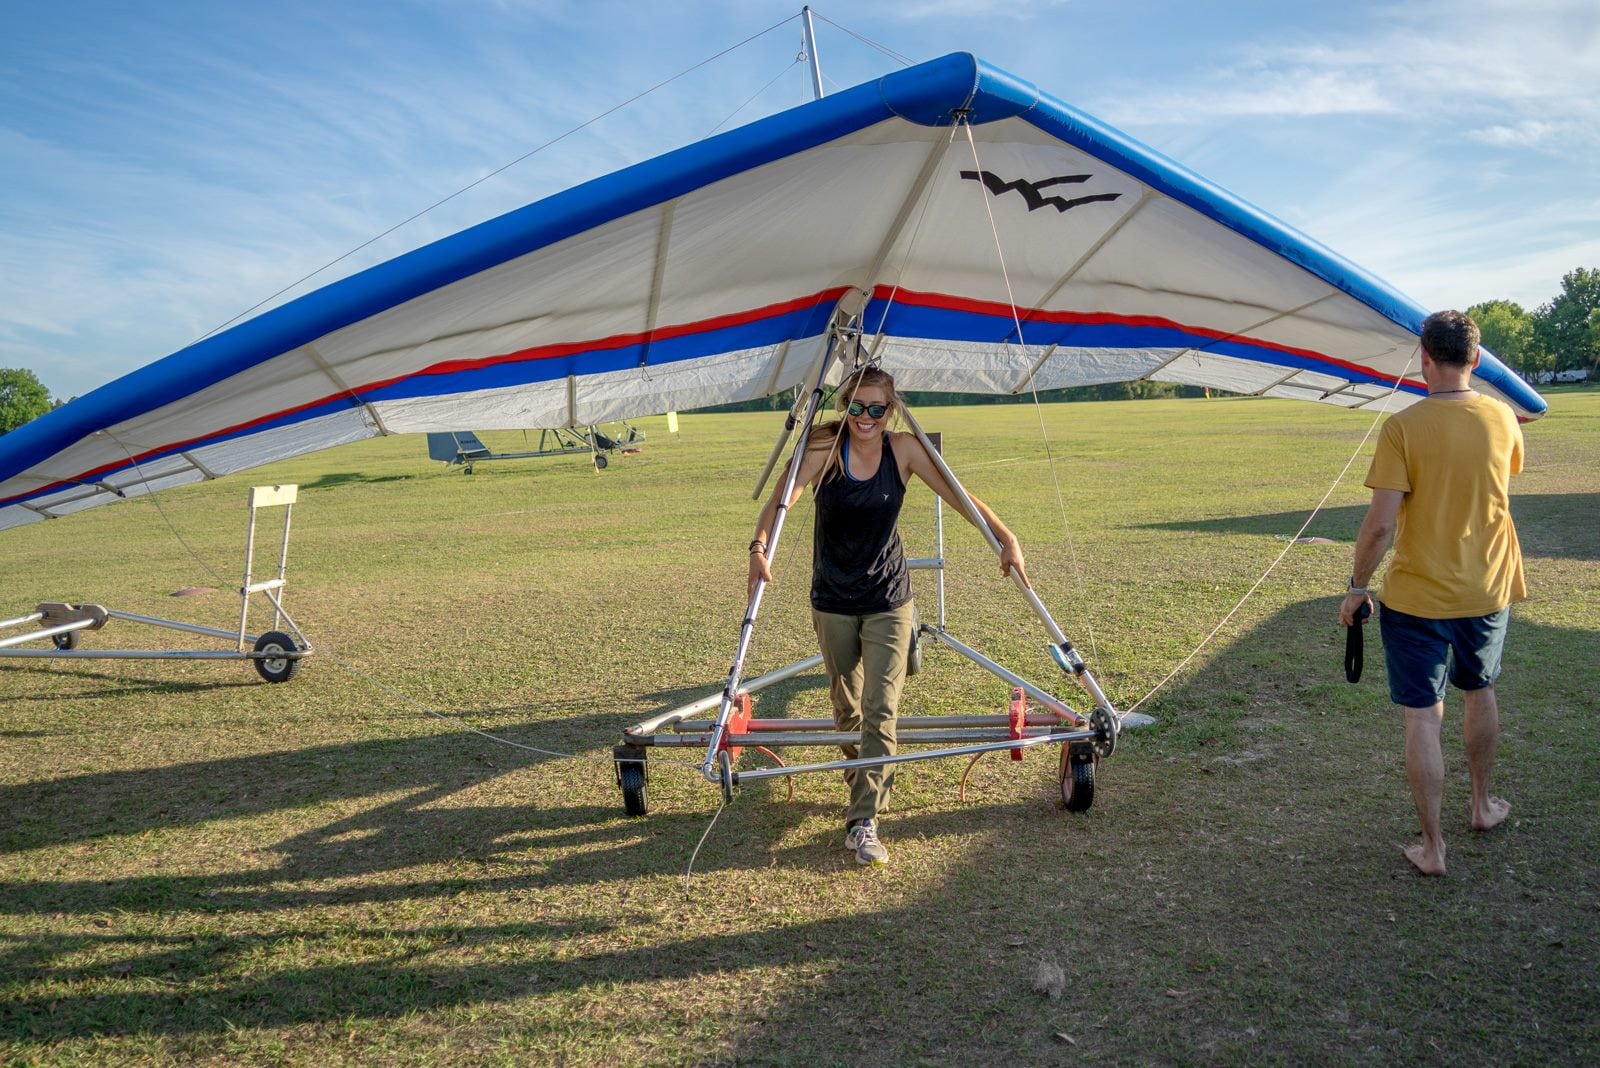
[1339,312,1526,875]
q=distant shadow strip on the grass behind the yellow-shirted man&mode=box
[1139,492,1600,560]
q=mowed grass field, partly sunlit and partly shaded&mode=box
[0,392,1600,1066]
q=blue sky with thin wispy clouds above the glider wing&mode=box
[0,0,1600,397]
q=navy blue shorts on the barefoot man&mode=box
[1378,604,1510,708]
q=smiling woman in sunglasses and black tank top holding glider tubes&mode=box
[749,366,1027,863]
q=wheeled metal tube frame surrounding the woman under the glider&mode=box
[613,327,1122,815]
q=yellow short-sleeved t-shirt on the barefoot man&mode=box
[1366,393,1528,619]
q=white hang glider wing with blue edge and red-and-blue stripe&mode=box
[0,54,1544,528]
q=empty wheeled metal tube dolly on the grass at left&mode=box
[0,484,312,683]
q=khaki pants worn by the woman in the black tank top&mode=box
[811,603,915,827]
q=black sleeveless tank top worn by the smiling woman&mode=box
[811,430,910,616]
